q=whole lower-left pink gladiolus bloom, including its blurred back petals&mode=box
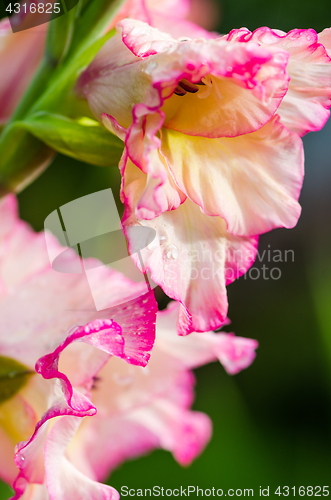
[0,197,257,500]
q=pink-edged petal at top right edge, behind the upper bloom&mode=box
[228,28,331,136]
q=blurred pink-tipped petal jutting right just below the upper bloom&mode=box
[157,302,258,375]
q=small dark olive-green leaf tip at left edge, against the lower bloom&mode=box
[0,356,34,404]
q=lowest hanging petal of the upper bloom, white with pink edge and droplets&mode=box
[124,193,257,334]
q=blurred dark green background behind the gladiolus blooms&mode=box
[0,0,331,499]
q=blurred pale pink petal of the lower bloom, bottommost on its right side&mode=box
[74,380,211,474]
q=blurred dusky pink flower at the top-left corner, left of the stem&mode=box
[0,19,47,125]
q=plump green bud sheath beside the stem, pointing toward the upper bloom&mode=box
[24,113,124,167]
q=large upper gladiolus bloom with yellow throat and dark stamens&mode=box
[78,19,316,334]
